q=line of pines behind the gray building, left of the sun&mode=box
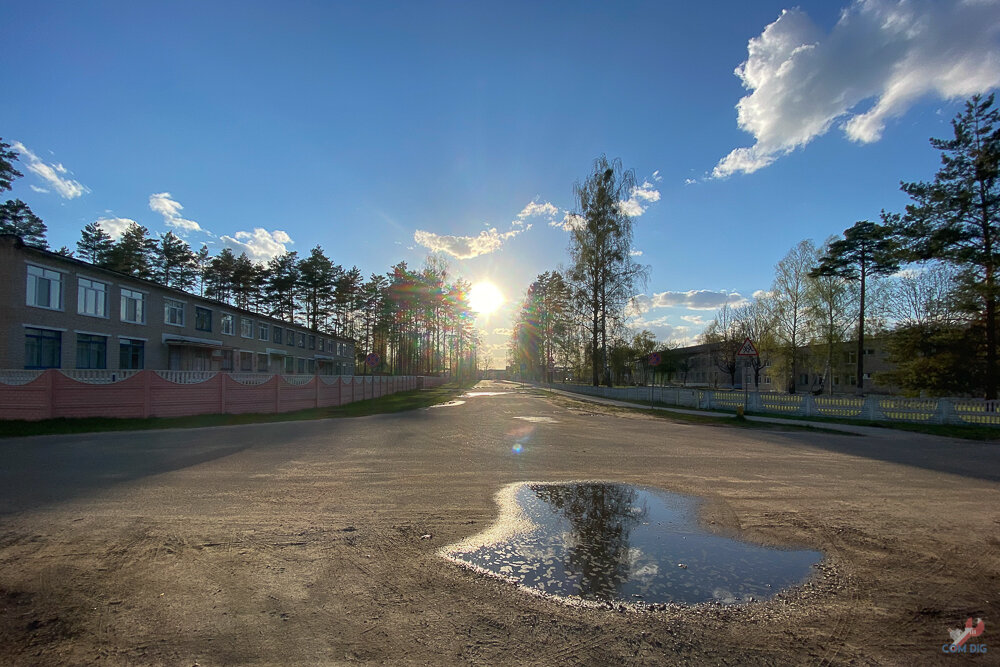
[0,141,480,379]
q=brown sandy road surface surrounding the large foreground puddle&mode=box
[0,383,1000,665]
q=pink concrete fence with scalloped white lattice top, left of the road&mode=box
[0,370,444,420]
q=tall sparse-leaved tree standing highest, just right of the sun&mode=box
[568,155,645,386]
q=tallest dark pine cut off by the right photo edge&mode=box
[900,95,1000,399]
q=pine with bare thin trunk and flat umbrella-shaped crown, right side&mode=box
[810,220,900,395]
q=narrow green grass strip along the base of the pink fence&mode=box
[0,384,469,438]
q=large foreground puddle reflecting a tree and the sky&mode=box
[442,482,823,604]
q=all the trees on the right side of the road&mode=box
[508,95,1000,399]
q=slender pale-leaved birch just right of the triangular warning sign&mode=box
[771,240,816,393]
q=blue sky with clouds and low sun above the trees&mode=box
[0,0,1000,366]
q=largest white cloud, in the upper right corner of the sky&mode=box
[712,0,1000,178]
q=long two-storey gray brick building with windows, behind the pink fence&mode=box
[0,235,355,375]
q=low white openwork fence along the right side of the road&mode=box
[551,384,1000,426]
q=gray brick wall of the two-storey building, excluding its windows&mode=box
[0,235,354,375]
